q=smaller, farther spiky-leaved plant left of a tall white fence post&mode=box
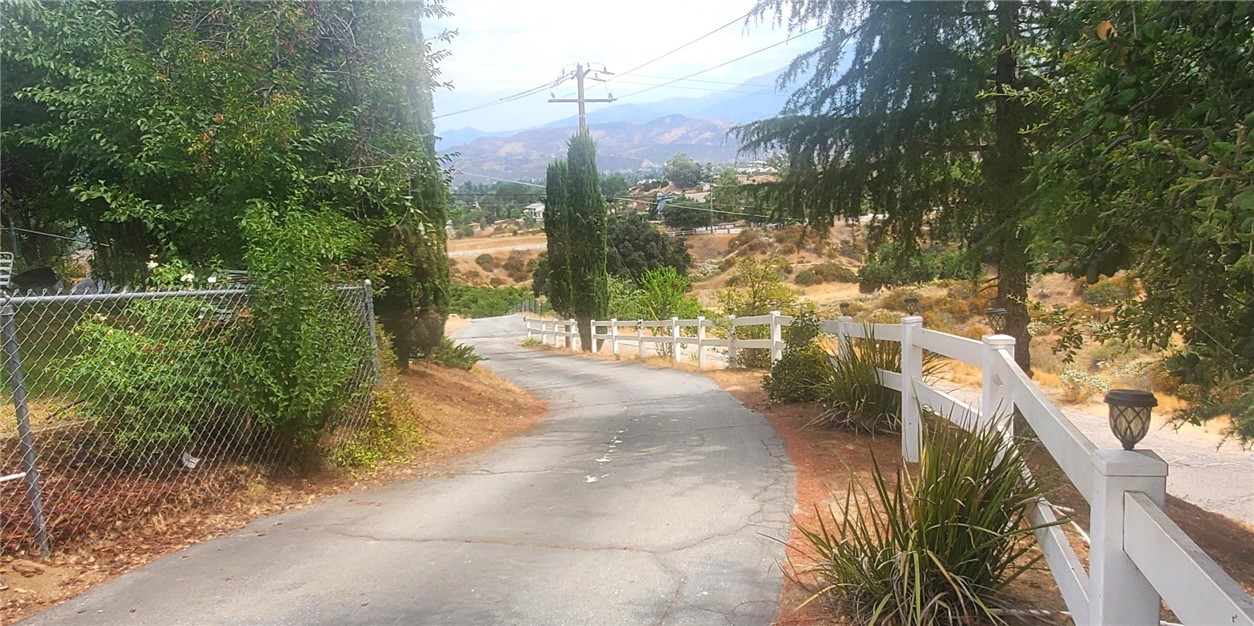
[810,325,938,433]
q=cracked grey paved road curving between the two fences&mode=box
[29,317,794,625]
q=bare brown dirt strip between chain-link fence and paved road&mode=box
[0,364,545,623]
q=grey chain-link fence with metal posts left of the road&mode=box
[0,282,379,554]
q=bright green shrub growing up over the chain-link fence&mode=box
[238,208,371,467]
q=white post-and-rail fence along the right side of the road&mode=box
[524,311,1254,626]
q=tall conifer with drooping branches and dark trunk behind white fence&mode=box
[739,0,1056,369]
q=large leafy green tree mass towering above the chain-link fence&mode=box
[0,0,448,360]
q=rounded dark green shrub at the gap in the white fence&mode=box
[762,312,831,403]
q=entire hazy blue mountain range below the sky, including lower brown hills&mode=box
[436,70,790,183]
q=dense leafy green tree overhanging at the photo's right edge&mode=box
[1022,1,1254,444]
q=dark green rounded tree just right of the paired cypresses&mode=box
[606,215,692,285]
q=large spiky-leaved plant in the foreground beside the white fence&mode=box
[795,424,1042,626]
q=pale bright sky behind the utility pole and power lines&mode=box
[425,0,821,132]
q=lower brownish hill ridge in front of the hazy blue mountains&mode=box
[450,115,739,183]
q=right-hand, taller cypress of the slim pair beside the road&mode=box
[566,132,609,351]
